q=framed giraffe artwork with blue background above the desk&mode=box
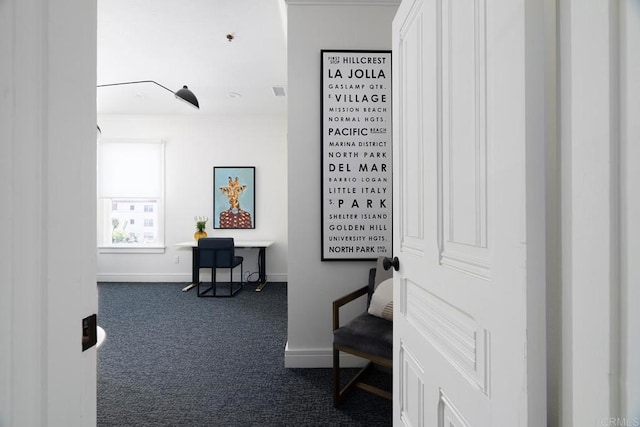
[213,166,256,229]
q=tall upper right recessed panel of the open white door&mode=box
[434,0,490,278]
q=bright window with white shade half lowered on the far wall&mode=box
[98,140,164,252]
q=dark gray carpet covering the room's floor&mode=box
[98,283,392,427]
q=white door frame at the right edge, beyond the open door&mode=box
[557,0,640,426]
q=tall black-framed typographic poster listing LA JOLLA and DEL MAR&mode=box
[321,50,393,261]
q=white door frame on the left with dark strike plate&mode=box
[0,0,97,426]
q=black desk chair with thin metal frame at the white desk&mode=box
[194,237,244,297]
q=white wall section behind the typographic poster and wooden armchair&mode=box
[285,0,399,367]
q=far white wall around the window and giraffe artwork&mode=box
[98,112,287,282]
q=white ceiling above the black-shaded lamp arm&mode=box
[96,0,287,115]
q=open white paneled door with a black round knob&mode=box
[393,0,546,426]
